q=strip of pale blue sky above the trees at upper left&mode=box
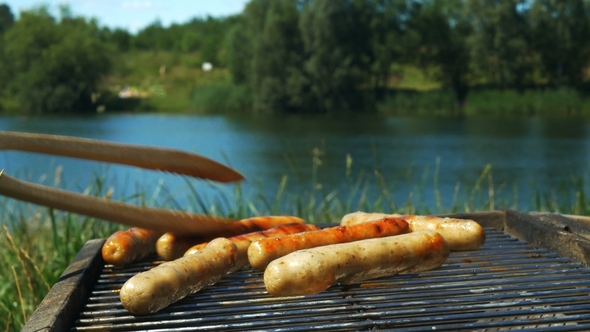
[0,0,248,33]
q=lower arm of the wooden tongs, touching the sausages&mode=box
[0,170,234,236]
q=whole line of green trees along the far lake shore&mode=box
[0,0,590,113]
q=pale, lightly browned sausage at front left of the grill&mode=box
[119,238,237,315]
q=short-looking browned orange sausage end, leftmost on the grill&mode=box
[102,227,160,266]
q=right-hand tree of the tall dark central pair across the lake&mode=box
[300,0,371,112]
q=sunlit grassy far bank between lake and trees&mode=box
[0,51,590,117]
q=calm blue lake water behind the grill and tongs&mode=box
[0,114,590,212]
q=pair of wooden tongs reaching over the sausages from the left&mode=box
[0,132,243,236]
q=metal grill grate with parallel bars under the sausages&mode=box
[72,228,590,331]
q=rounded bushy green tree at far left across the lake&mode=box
[4,8,112,113]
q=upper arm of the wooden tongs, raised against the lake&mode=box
[0,132,244,182]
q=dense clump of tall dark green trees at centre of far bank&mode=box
[236,0,393,113]
